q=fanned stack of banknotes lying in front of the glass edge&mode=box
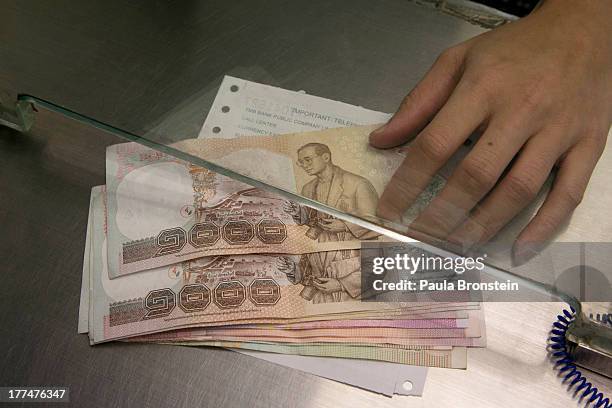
[79,129,485,368]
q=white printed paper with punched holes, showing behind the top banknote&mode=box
[198,75,391,138]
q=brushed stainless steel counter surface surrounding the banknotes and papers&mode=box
[0,0,612,407]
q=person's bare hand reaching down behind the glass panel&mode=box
[370,0,612,263]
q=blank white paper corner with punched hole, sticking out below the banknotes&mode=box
[233,349,427,397]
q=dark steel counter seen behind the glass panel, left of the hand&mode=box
[0,0,483,137]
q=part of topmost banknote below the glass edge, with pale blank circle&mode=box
[106,143,377,279]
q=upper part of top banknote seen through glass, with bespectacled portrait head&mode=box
[172,126,460,230]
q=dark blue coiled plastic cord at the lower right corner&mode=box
[550,307,612,408]
